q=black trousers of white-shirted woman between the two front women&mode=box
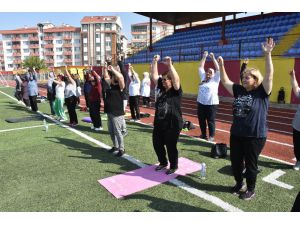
[197,102,218,137]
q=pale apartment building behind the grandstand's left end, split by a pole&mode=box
[131,21,174,49]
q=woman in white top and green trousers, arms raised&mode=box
[53,74,67,121]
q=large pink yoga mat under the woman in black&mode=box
[98,158,201,198]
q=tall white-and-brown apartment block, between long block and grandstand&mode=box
[80,16,123,66]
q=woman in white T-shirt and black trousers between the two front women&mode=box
[197,51,220,141]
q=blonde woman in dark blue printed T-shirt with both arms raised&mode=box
[218,38,275,200]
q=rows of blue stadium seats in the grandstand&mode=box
[126,12,300,63]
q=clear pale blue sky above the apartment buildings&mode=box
[0,12,149,40]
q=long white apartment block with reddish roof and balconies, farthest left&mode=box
[0,23,82,71]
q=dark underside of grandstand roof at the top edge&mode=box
[136,12,237,26]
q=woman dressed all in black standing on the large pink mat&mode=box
[151,55,183,174]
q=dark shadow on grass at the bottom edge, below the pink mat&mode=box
[125,194,211,212]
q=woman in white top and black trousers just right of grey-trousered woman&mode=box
[128,64,141,121]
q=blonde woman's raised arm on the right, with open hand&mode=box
[262,38,275,95]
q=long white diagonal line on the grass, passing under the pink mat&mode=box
[0,91,243,212]
